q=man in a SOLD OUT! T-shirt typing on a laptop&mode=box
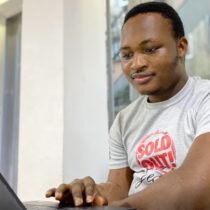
[46,2,210,210]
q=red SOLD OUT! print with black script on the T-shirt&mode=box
[136,131,176,188]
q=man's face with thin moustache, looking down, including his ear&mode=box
[120,13,187,102]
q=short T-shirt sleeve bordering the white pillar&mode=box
[109,113,128,169]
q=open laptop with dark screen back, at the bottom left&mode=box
[0,173,135,210]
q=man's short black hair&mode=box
[123,2,185,39]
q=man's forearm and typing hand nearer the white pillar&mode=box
[46,167,133,206]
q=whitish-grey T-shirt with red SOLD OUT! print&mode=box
[109,77,210,194]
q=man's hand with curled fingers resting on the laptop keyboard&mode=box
[45,177,107,206]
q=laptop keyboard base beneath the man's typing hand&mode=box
[24,201,135,210]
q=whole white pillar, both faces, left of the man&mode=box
[13,0,108,201]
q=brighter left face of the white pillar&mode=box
[17,0,63,200]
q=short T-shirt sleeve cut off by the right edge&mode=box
[195,94,210,137]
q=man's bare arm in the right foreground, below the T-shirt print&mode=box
[113,133,210,210]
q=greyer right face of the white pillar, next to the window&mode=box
[64,0,108,182]
